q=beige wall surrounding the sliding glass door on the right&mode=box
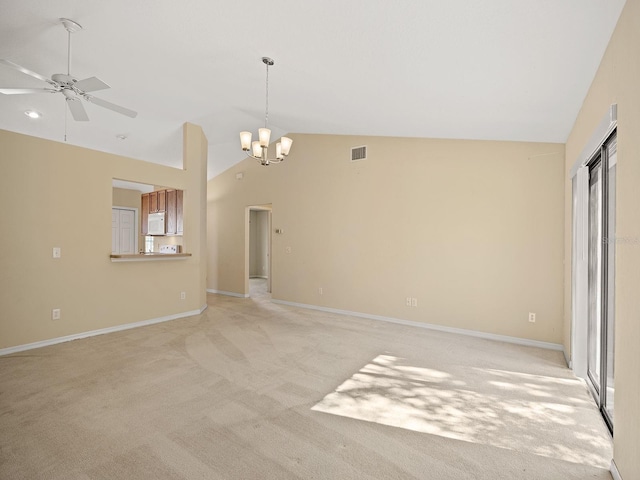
[564,0,640,480]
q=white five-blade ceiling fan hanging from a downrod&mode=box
[0,18,138,122]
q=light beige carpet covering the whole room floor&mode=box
[0,284,611,480]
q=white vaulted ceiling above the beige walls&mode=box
[0,0,624,178]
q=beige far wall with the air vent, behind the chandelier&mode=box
[207,135,564,343]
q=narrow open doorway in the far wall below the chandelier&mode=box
[245,204,272,298]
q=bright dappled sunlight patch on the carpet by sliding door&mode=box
[312,354,610,468]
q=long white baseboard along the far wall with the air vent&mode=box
[271,300,564,352]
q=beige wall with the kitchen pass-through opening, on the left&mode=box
[0,124,206,348]
